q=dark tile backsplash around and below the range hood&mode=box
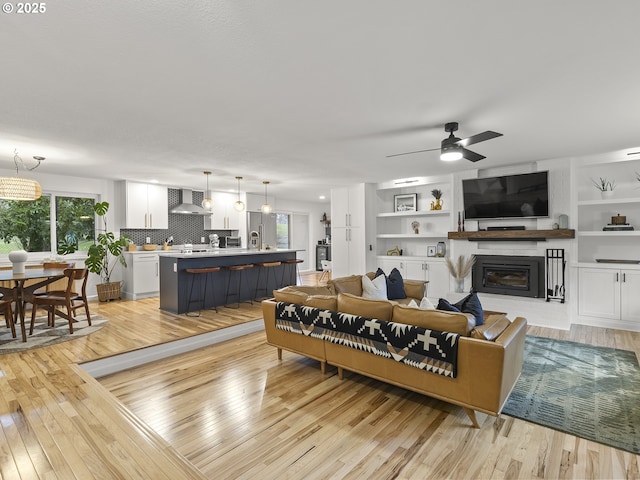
[120,188,237,245]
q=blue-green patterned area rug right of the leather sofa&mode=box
[502,335,640,454]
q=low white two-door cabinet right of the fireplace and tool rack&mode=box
[578,267,640,322]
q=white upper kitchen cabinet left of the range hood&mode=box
[122,181,169,229]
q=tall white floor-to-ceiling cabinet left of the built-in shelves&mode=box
[331,183,368,278]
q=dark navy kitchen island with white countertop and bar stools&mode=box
[159,248,297,313]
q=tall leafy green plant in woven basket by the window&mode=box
[84,202,129,302]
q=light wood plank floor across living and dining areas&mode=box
[0,276,640,480]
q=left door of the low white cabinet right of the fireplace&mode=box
[578,268,620,320]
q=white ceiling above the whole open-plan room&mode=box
[0,0,640,201]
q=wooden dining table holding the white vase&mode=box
[0,268,64,342]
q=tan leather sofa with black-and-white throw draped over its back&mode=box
[262,287,527,427]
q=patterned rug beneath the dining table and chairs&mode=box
[0,315,108,354]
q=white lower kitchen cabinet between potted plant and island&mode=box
[123,253,160,300]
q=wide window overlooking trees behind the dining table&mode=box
[0,194,95,253]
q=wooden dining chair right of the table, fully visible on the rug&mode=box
[29,268,91,335]
